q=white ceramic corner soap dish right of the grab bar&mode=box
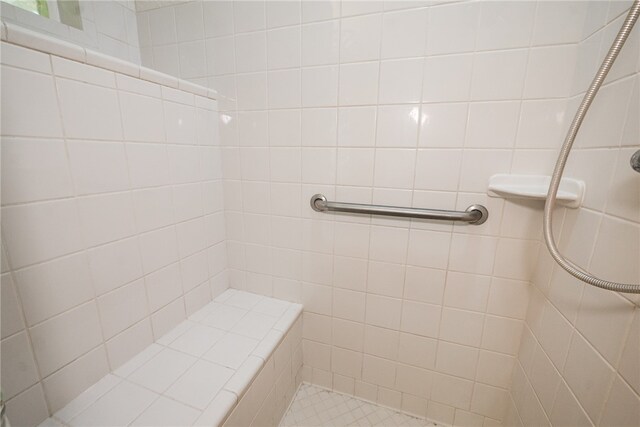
[487,173,585,208]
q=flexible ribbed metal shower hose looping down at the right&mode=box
[543,0,640,294]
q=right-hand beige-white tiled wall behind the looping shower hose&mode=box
[505,2,640,426]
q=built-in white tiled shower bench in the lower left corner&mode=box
[41,289,302,427]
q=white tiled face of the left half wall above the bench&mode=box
[1,39,227,426]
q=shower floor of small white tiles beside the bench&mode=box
[280,384,437,427]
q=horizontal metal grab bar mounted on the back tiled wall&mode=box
[311,194,489,225]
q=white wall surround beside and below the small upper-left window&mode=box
[0,0,140,64]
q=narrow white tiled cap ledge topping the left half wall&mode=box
[0,21,218,99]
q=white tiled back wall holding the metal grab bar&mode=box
[138,1,638,425]
